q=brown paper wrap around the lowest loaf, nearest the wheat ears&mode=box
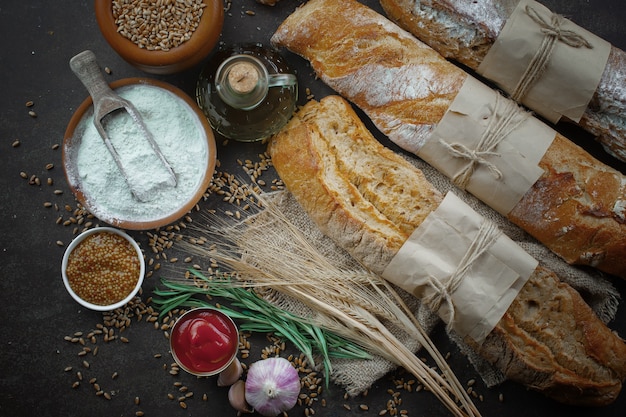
[382,193,538,344]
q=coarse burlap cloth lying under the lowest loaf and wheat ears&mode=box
[245,151,620,396]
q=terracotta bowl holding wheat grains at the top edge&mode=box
[94,0,224,75]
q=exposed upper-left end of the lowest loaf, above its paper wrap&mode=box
[268,97,443,274]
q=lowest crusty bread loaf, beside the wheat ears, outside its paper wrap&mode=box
[268,96,626,405]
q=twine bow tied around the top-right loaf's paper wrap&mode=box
[511,5,593,101]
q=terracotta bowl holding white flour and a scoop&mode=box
[62,78,217,230]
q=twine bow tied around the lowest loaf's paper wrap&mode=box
[423,219,502,329]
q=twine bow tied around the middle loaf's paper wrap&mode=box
[439,94,530,190]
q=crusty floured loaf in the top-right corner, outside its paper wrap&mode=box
[380,0,626,161]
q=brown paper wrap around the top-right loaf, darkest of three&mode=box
[477,0,611,123]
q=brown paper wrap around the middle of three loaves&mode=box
[418,77,556,215]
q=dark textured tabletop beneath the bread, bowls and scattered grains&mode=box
[0,0,626,417]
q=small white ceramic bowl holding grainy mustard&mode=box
[61,227,146,311]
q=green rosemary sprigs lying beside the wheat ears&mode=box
[152,270,371,385]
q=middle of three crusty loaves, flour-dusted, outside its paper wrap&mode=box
[272,0,626,278]
